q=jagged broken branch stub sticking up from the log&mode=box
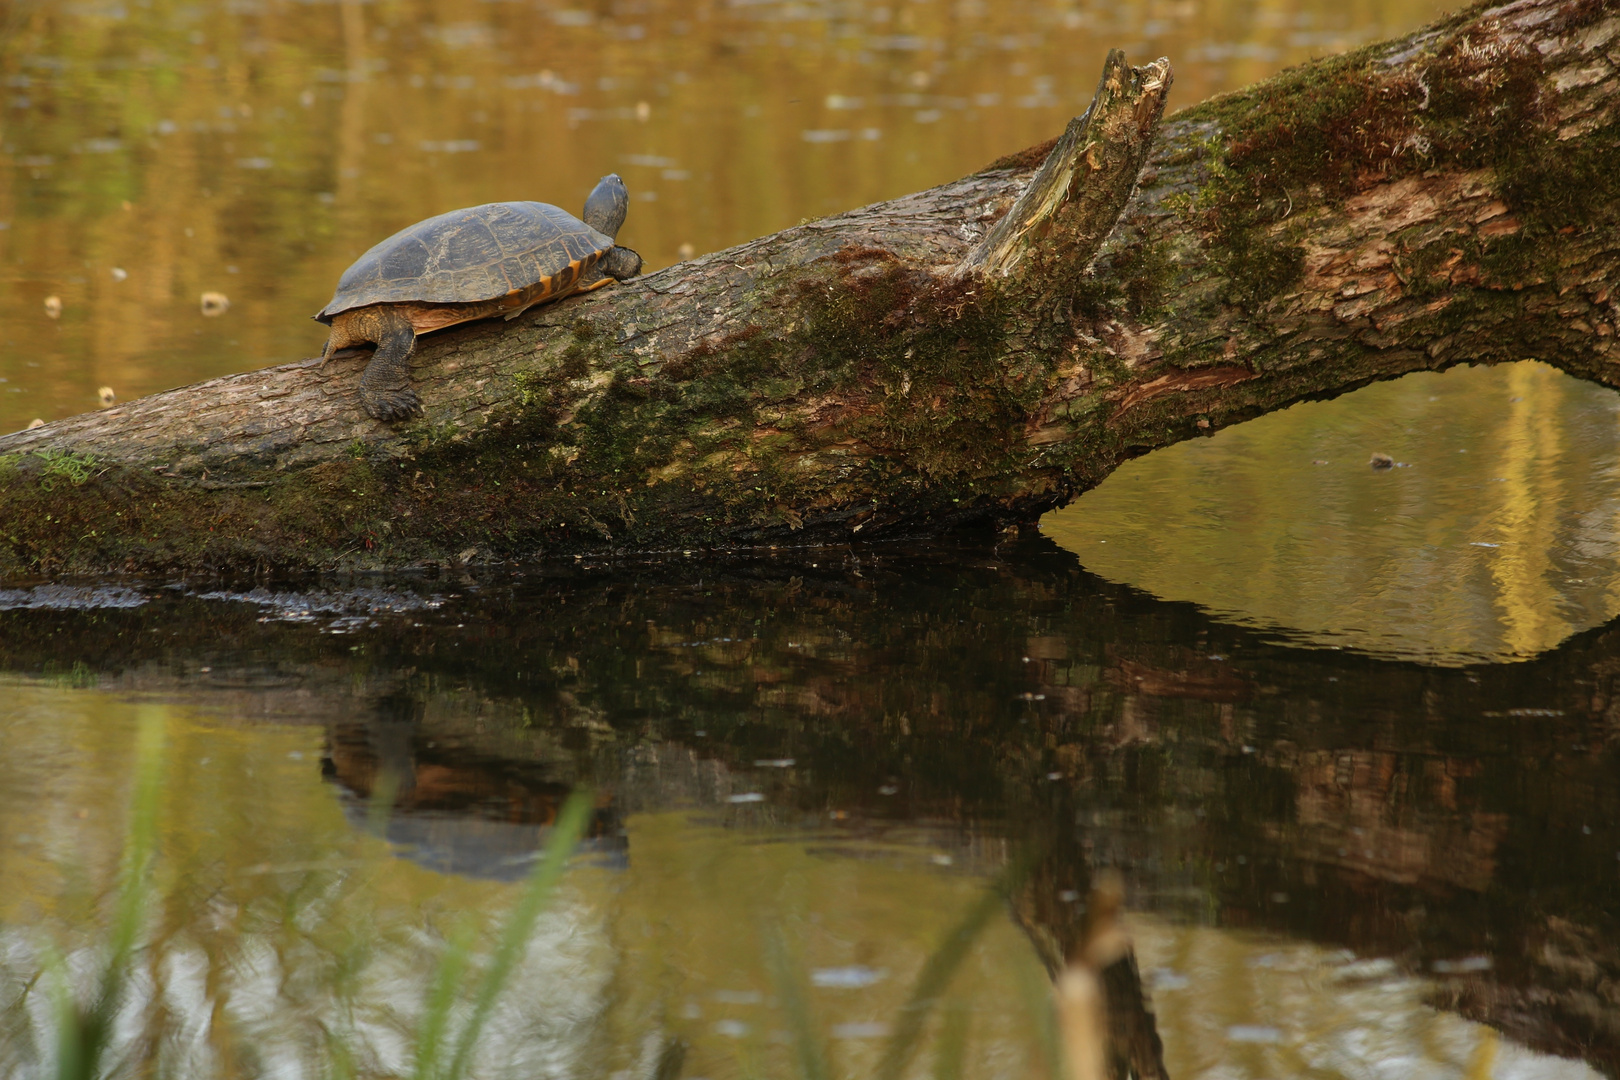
[957,49,1175,277]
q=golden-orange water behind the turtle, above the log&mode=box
[0,0,1447,431]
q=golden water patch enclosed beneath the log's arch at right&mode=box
[1043,363,1620,664]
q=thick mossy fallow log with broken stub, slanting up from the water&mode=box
[0,0,1620,576]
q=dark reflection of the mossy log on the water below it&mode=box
[0,550,1620,1074]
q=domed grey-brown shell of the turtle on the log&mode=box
[316,202,614,325]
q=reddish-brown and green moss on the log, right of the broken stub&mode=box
[1176,3,1620,304]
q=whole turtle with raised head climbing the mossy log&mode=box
[316,173,642,419]
